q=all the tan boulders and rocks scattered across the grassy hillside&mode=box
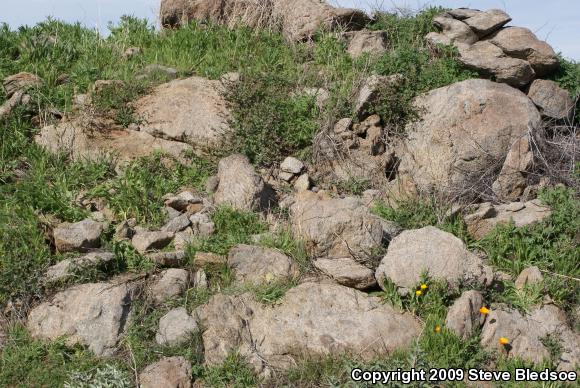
[0,0,580,386]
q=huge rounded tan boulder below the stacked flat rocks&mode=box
[398,79,542,195]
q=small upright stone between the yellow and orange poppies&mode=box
[445,290,485,339]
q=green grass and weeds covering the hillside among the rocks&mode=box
[0,9,580,387]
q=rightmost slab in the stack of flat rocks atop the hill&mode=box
[489,27,560,77]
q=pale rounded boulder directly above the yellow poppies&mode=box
[375,226,493,293]
